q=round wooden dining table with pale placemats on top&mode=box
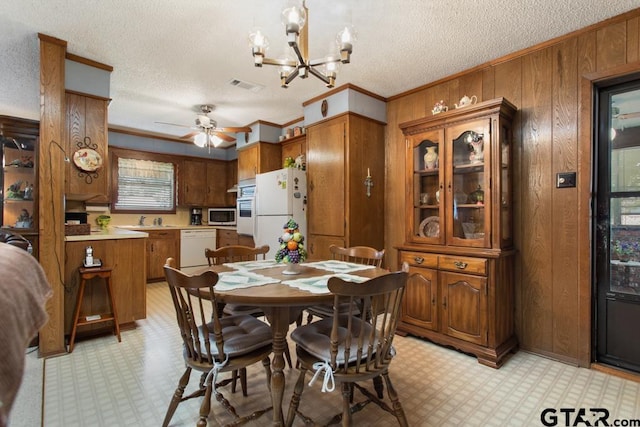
[203,259,389,426]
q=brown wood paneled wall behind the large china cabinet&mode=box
[385,9,640,366]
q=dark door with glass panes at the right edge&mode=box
[593,75,640,372]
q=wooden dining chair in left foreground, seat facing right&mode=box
[162,258,272,427]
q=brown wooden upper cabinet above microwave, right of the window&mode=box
[178,159,228,207]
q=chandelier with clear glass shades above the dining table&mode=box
[249,0,355,88]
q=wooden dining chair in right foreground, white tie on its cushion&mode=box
[286,263,409,426]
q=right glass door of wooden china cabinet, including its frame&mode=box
[446,120,491,247]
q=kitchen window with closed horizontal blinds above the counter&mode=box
[113,156,176,212]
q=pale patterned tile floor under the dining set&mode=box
[11,283,640,427]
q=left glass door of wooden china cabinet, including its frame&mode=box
[407,130,446,244]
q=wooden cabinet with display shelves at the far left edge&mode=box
[0,116,39,257]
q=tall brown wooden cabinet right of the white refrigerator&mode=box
[306,113,384,260]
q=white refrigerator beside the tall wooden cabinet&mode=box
[253,168,307,258]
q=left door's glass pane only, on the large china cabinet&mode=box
[413,137,441,238]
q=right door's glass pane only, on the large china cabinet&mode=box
[451,130,485,240]
